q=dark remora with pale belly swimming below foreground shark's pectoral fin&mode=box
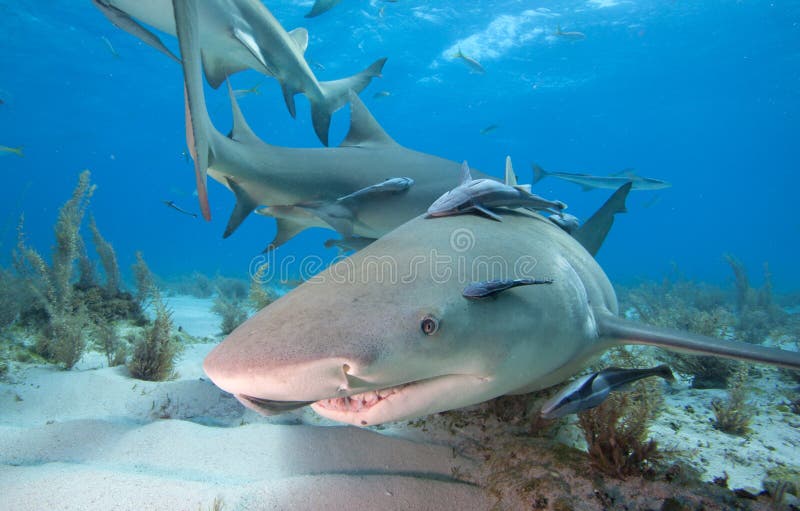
[541,365,675,419]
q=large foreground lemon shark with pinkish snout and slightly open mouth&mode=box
[203,211,800,426]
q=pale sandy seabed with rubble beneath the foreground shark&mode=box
[0,296,800,510]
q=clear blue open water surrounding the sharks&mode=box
[0,0,800,289]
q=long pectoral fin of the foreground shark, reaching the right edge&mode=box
[595,312,800,370]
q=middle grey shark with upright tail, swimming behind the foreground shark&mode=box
[170,2,488,242]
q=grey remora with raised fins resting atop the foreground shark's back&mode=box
[428,157,567,221]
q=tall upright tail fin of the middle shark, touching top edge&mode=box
[172,0,213,220]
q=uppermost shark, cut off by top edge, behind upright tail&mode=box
[92,0,386,145]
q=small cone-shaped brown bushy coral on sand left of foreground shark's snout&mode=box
[128,292,181,381]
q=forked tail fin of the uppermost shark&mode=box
[310,57,386,146]
